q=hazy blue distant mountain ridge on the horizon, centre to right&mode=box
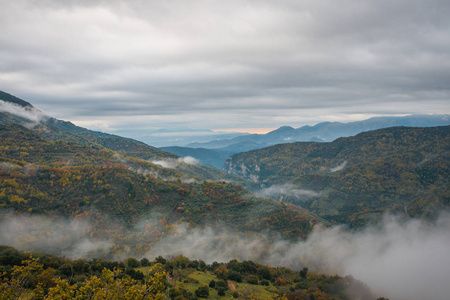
[165,115,450,169]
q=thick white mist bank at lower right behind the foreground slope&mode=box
[148,213,450,300]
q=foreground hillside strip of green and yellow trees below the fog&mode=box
[0,246,384,300]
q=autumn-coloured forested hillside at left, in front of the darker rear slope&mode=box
[0,124,313,257]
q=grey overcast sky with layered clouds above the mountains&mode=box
[0,0,450,132]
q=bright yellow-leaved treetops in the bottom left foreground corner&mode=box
[0,257,167,300]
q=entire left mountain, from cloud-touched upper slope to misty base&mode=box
[0,90,317,258]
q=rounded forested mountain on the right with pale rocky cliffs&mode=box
[224,126,450,225]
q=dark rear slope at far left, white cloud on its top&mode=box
[0,91,250,183]
